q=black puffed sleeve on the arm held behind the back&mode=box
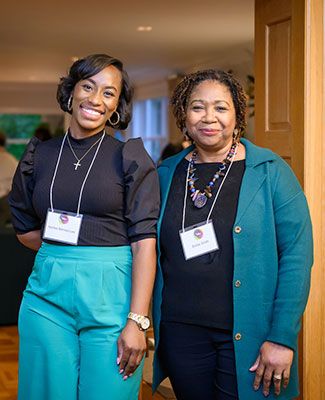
[9,137,41,234]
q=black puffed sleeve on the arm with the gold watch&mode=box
[122,138,160,243]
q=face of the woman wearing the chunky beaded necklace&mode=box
[185,80,236,153]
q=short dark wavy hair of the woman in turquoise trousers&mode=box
[56,54,133,129]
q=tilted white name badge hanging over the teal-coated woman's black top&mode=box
[179,221,219,260]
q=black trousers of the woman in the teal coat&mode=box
[158,322,238,400]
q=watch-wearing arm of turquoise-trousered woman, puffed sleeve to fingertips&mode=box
[117,139,159,379]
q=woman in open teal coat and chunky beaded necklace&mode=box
[153,70,312,400]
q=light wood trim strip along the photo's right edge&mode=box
[303,0,325,400]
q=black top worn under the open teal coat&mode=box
[160,159,245,330]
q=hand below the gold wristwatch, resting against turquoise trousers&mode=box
[117,320,147,380]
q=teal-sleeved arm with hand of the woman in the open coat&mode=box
[250,160,313,395]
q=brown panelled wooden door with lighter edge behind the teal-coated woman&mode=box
[255,0,325,400]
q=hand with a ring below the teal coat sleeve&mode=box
[249,342,293,396]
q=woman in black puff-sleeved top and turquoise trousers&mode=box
[10,54,159,400]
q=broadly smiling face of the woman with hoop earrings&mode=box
[70,65,122,138]
